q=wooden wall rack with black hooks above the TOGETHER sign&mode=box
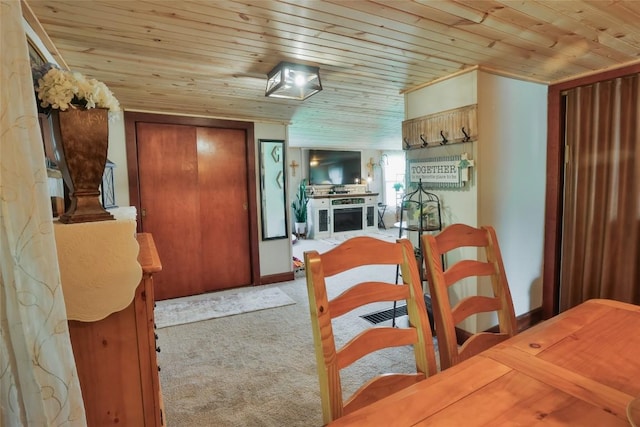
[402,104,478,150]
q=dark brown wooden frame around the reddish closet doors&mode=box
[124,111,260,286]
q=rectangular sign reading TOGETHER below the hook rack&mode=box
[409,156,464,187]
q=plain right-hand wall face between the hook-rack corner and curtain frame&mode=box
[477,72,547,315]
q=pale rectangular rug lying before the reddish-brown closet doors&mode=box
[154,287,295,328]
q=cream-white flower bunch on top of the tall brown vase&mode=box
[33,64,120,111]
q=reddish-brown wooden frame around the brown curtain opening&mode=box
[542,63,640,319]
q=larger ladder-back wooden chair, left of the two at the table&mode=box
[304,237,436,423]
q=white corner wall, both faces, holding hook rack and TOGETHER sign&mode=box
[405,71,547,332]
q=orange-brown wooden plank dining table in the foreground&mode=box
[329,299,640,427]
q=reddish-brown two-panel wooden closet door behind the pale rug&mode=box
[136,122,252,300]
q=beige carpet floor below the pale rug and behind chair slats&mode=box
[157,231,438,427]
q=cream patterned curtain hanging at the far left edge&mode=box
[0,0,86,427]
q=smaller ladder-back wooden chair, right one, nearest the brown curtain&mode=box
[422,224,517,369]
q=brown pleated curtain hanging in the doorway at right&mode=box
[560,74,640,311]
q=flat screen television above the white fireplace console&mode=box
[309,150,362,185]
